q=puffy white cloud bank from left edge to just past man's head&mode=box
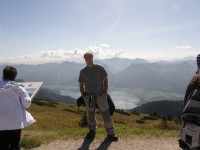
[0,44,126,64]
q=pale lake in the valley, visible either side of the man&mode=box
[59,90,140,109]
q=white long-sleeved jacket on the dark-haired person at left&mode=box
[0,81,35,130]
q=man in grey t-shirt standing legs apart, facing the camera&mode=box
[79,52,118,141]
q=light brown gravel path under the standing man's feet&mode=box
[32,137,181,150]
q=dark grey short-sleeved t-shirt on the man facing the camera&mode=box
[78,65,107,95]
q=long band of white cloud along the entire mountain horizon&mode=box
[0,44,198,64]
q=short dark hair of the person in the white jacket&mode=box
[3,66,17,81]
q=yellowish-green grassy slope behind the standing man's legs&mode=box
[21,100,180,148]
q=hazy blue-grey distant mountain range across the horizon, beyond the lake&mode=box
[0,58,196,93]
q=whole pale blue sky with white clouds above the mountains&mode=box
[0,0,200,63]
